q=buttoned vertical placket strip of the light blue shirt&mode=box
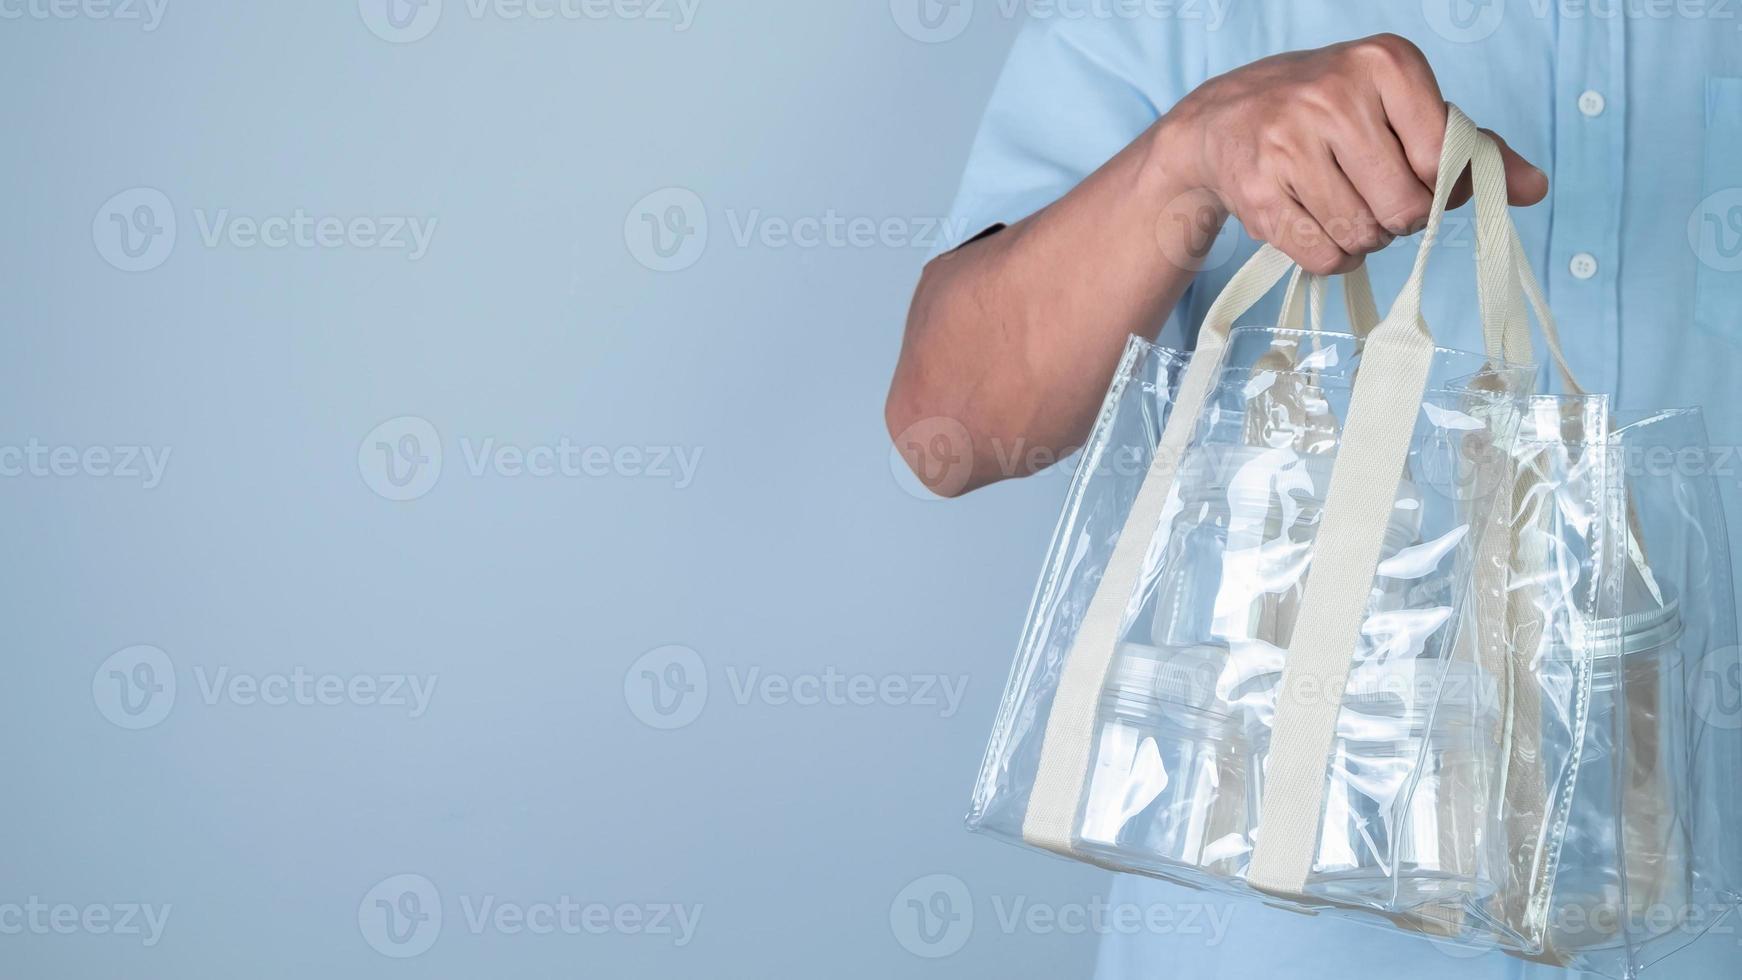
[1547,5,1627,392]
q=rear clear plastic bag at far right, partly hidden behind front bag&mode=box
[1538,400,1742,978]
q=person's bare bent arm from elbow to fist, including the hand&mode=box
[885,35,1549,496]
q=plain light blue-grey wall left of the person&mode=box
[0,0,1106,980]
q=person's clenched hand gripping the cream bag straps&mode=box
[1151,35,1549,275]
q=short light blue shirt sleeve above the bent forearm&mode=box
[939,17,1205,344]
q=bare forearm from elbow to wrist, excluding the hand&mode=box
[887,118,1226,494]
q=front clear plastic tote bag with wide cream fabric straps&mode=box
[969,108,1618,954]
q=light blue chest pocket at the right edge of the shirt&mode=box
[1688,78,1742,343]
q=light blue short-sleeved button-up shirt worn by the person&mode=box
[951,0,1742,980]
